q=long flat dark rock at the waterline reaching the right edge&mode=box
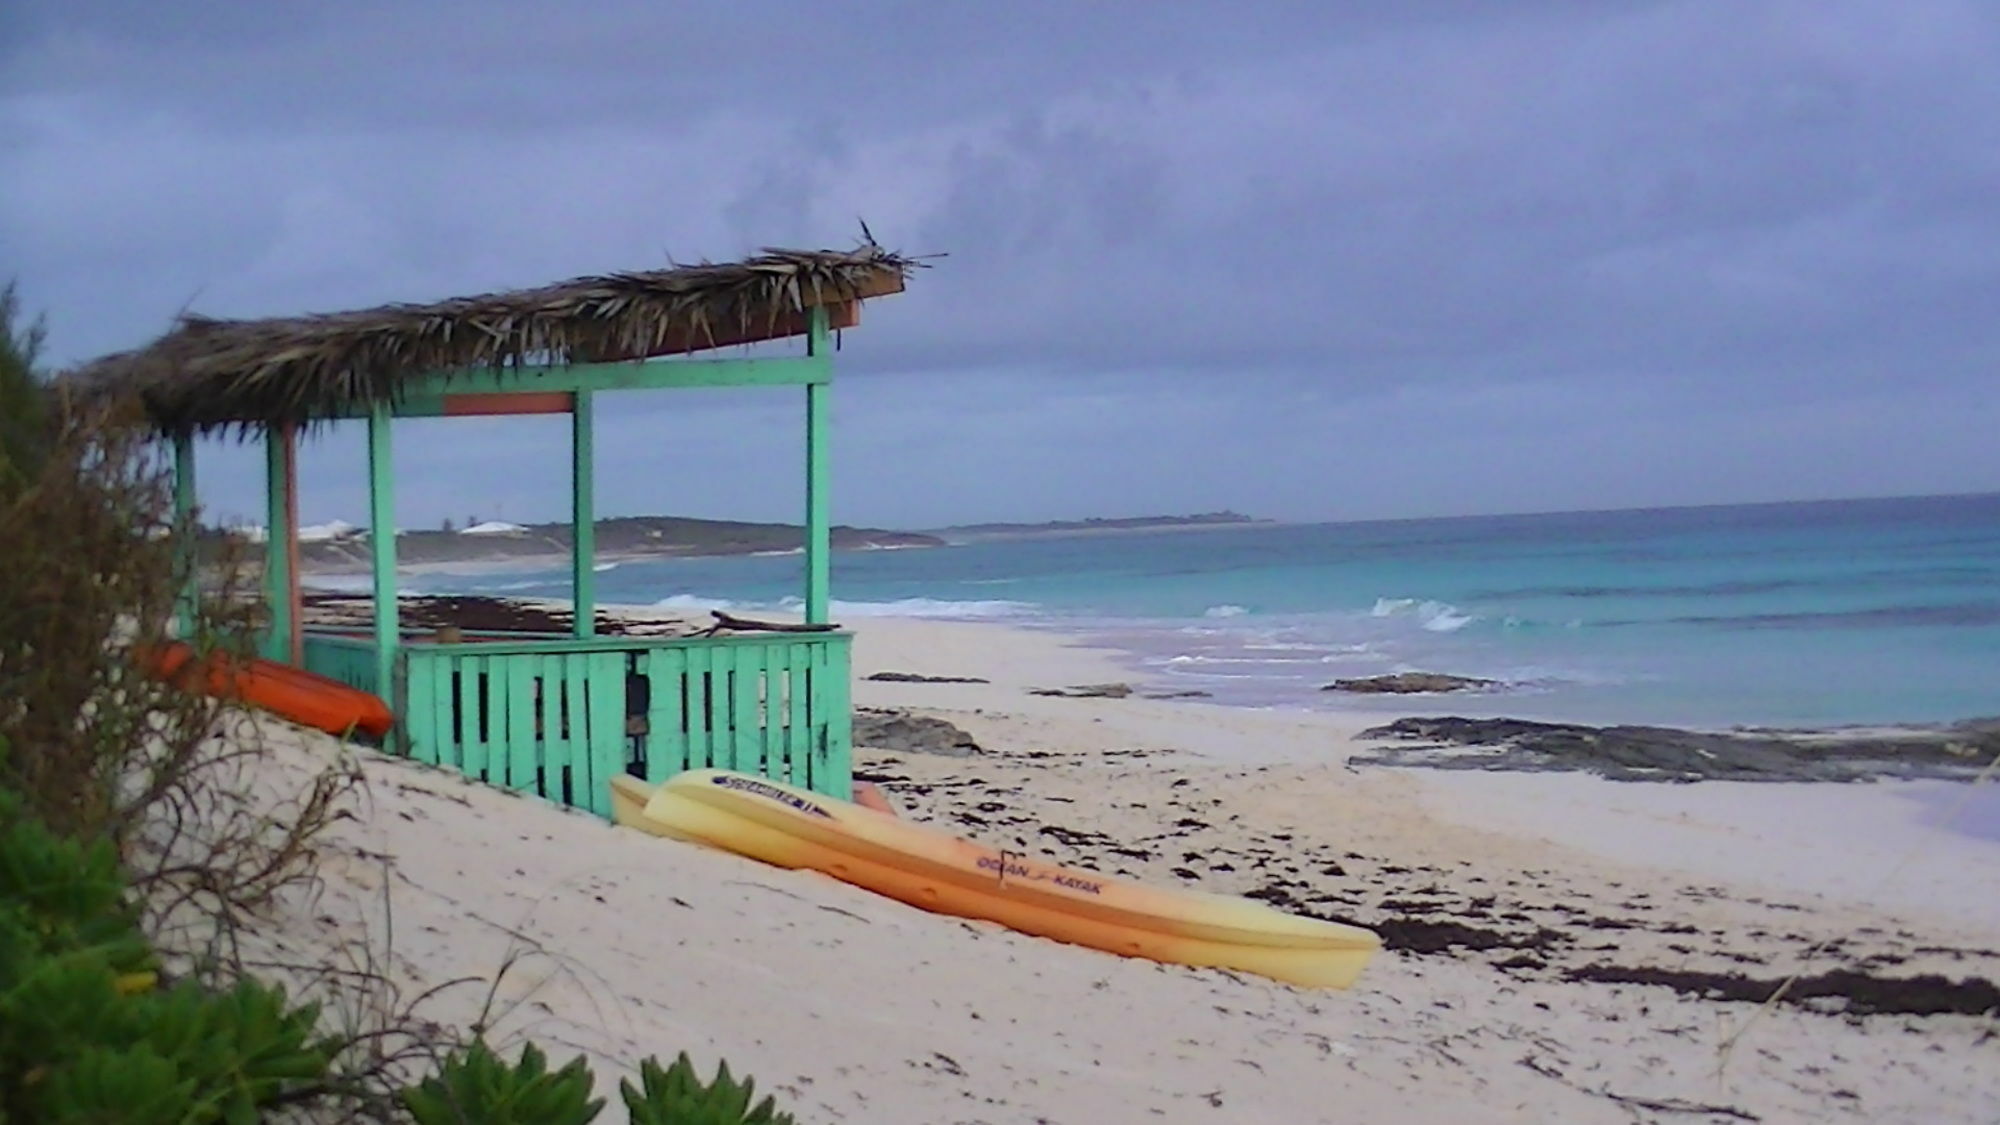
[1354,717,2000,781]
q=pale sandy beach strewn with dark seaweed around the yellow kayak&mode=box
[227,619,2000,1125]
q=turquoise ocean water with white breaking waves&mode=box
[378,494,2000,727]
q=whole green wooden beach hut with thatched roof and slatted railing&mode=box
[72,240,922,815]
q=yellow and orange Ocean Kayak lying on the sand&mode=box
[612,769,1382,989]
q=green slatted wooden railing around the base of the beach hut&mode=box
[306,633,854,817]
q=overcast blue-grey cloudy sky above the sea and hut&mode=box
[0,0,2000,526]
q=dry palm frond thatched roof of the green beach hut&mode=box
[62,240,922,432]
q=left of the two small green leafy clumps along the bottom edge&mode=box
[402,1039,604,1125]
